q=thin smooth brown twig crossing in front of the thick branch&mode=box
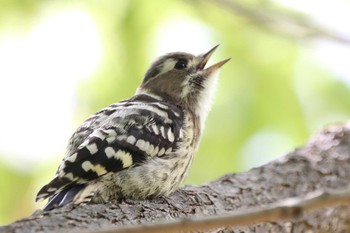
[94,189,350,233]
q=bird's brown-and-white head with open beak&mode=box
[137,45,230,122]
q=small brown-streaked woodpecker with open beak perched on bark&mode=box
[36,45,230,210]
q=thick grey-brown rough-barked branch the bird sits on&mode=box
[0,123,350,233]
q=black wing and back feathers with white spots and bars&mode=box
[37,95,182,202]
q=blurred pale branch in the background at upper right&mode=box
[192,0,350,45]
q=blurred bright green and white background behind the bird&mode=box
[0,0,350,224]
